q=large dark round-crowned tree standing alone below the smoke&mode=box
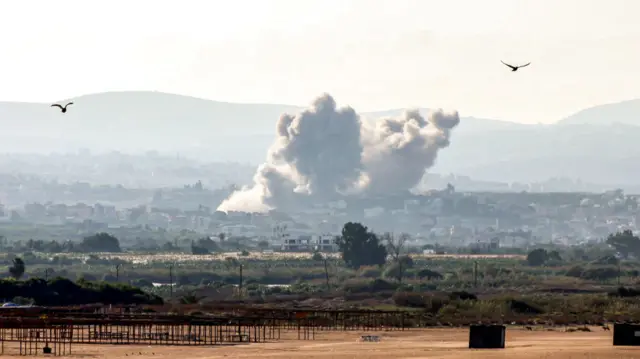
[337,222,387,268]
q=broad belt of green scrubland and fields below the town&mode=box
[0,223,640,324]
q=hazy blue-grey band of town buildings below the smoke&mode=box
[0,187,640,251]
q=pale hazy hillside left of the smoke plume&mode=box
[0,92,294,157]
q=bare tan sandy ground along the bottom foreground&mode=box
[3,328,640,359]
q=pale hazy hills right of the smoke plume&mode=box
[372,100,640,185]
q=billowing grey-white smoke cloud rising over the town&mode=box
[218,94,460,212]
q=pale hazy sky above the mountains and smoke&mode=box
[0,0,640,122]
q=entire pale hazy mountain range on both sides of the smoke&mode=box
[0,92,640,184]
